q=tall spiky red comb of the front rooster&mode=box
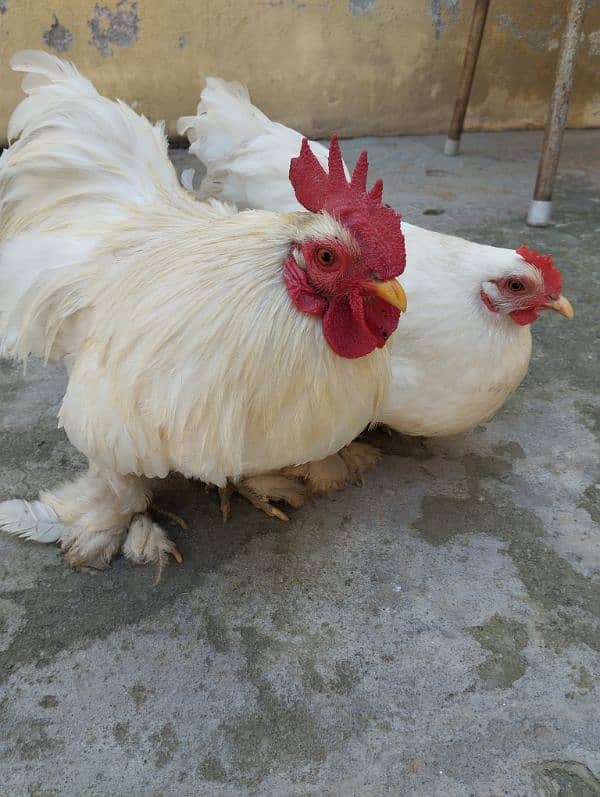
[289,136,406,279]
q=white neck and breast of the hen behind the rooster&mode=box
[377,224,531,437]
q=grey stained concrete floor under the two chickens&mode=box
[0,130,600,797]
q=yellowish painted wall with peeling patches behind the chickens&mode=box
[0,0,600,143]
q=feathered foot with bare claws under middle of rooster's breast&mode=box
[219,473,310,522]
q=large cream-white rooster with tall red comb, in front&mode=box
[0,51,405,568]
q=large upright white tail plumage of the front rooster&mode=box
[0,50,188,360]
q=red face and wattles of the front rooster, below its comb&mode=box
[283,238,400,359]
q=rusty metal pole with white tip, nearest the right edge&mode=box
[527,0,586,227]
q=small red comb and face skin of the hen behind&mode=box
[481,246,562,326]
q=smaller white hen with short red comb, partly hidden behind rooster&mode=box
[178,78,573,504]
